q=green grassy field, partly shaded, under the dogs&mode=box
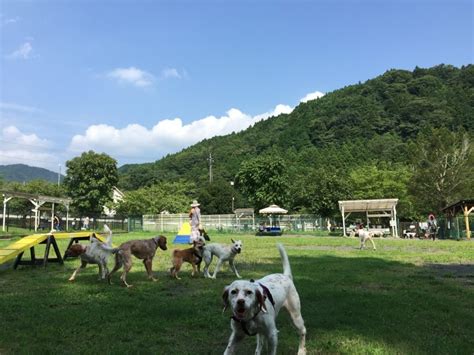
[0,233,474,354]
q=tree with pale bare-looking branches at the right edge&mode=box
[410,128,474,214]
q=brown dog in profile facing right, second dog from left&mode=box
[107,235,168,287]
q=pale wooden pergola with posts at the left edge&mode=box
[2,191,72,232]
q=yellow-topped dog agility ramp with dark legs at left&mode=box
[0,232,105,269]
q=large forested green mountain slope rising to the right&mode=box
[119,64,474,190]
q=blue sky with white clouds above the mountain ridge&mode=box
[0,0,474,171]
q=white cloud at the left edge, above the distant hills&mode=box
[0,126,58,169]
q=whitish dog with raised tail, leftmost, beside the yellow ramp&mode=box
[66,224,118,281]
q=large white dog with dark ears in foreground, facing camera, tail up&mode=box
[222,244,306,355]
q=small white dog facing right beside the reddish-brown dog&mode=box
[202,239,242,279]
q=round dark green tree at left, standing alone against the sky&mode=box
[64,151,118,214]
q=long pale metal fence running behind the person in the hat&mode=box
[143,213,327,233]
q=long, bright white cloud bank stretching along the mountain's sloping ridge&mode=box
[69,101,293,159]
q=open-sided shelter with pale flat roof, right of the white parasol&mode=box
[339,198,398,237]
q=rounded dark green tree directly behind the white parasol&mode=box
[236,155,289,209]
